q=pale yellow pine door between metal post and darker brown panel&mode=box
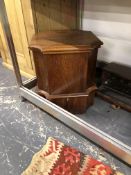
[4,0,34,75]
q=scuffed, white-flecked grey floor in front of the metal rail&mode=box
[0,59,131,175]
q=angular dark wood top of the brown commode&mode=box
[29,30,103,54]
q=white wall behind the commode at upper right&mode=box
[83,0,131,66]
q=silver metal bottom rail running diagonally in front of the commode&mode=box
[20,87,131,164]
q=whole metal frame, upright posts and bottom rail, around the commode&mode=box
[0,0,131,165]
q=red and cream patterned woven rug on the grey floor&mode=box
[22,137,122,175]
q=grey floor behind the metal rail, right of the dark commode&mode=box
[78,95,131,146]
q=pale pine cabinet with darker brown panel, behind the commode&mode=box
[0,0,79,77]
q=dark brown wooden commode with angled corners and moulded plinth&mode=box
[30,30,103,113]
